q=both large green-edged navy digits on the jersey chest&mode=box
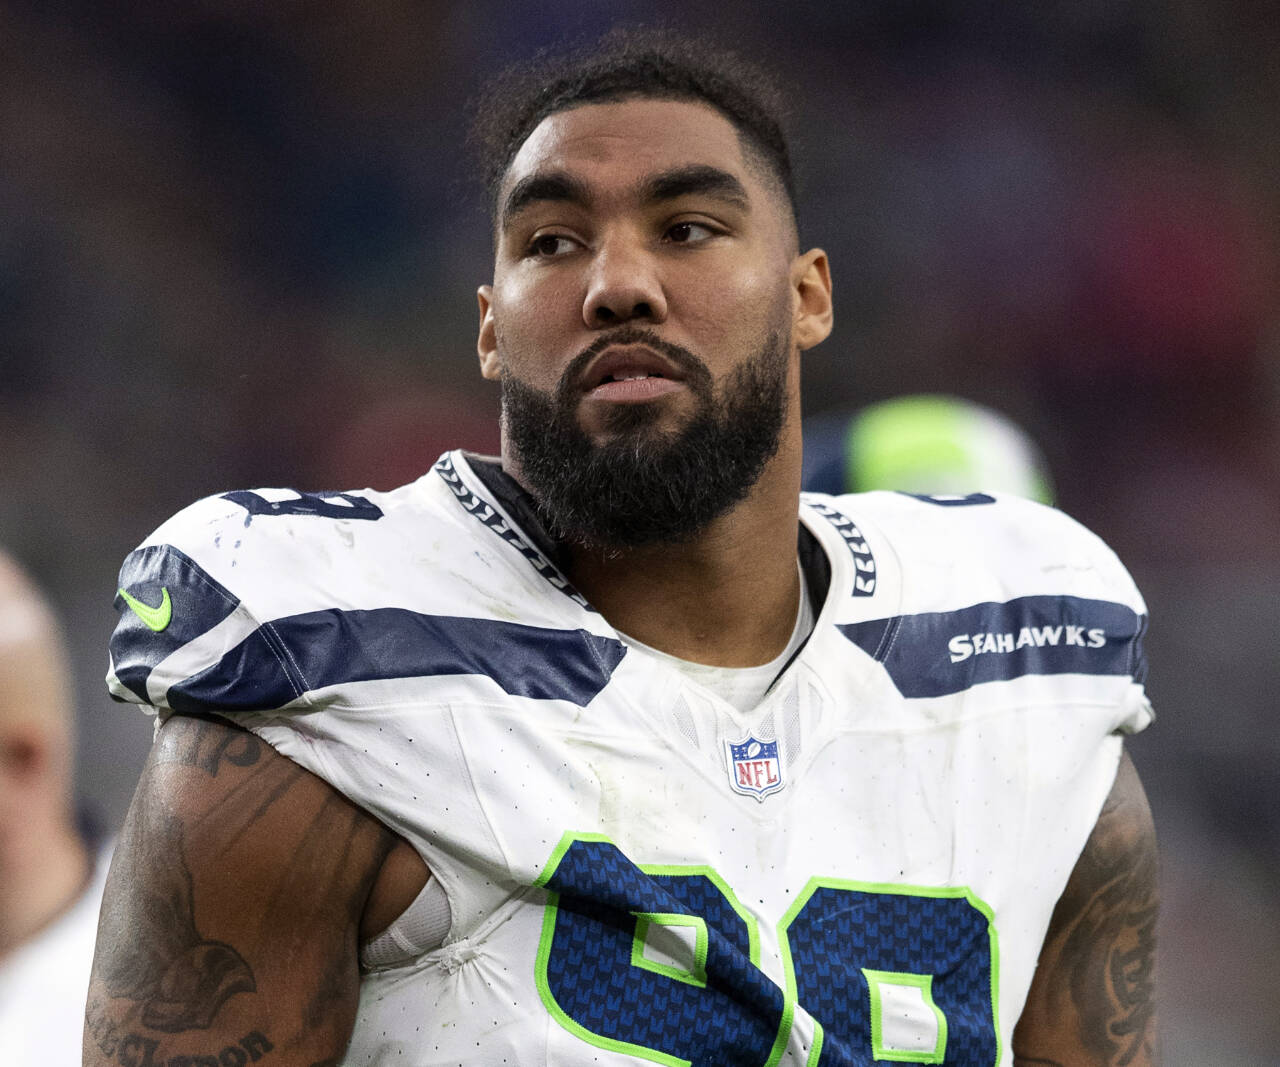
[536,834,1000,1067]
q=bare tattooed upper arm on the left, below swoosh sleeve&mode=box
[84,716,393,1067]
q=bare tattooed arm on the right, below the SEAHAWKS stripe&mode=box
[1014,754,1158,1067]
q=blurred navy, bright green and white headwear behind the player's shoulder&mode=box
[801,394,1053,504]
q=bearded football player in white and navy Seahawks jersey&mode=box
[84,27,1156,1067]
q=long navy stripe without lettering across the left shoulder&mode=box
[168,608,626,711]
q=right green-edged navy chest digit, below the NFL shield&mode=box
[782,880,1000,1067]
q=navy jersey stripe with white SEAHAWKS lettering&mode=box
[838,596,1147,697]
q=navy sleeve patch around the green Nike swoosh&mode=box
[110,545,239,702]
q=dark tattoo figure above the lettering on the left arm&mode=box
[100,818,257,1034]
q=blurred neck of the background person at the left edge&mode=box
[0,808,90,958]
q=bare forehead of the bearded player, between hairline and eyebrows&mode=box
[500,99,759,197]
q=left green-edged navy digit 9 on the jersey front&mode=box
[538,838,785,1067]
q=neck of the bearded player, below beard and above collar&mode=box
[568,449,800,667]
